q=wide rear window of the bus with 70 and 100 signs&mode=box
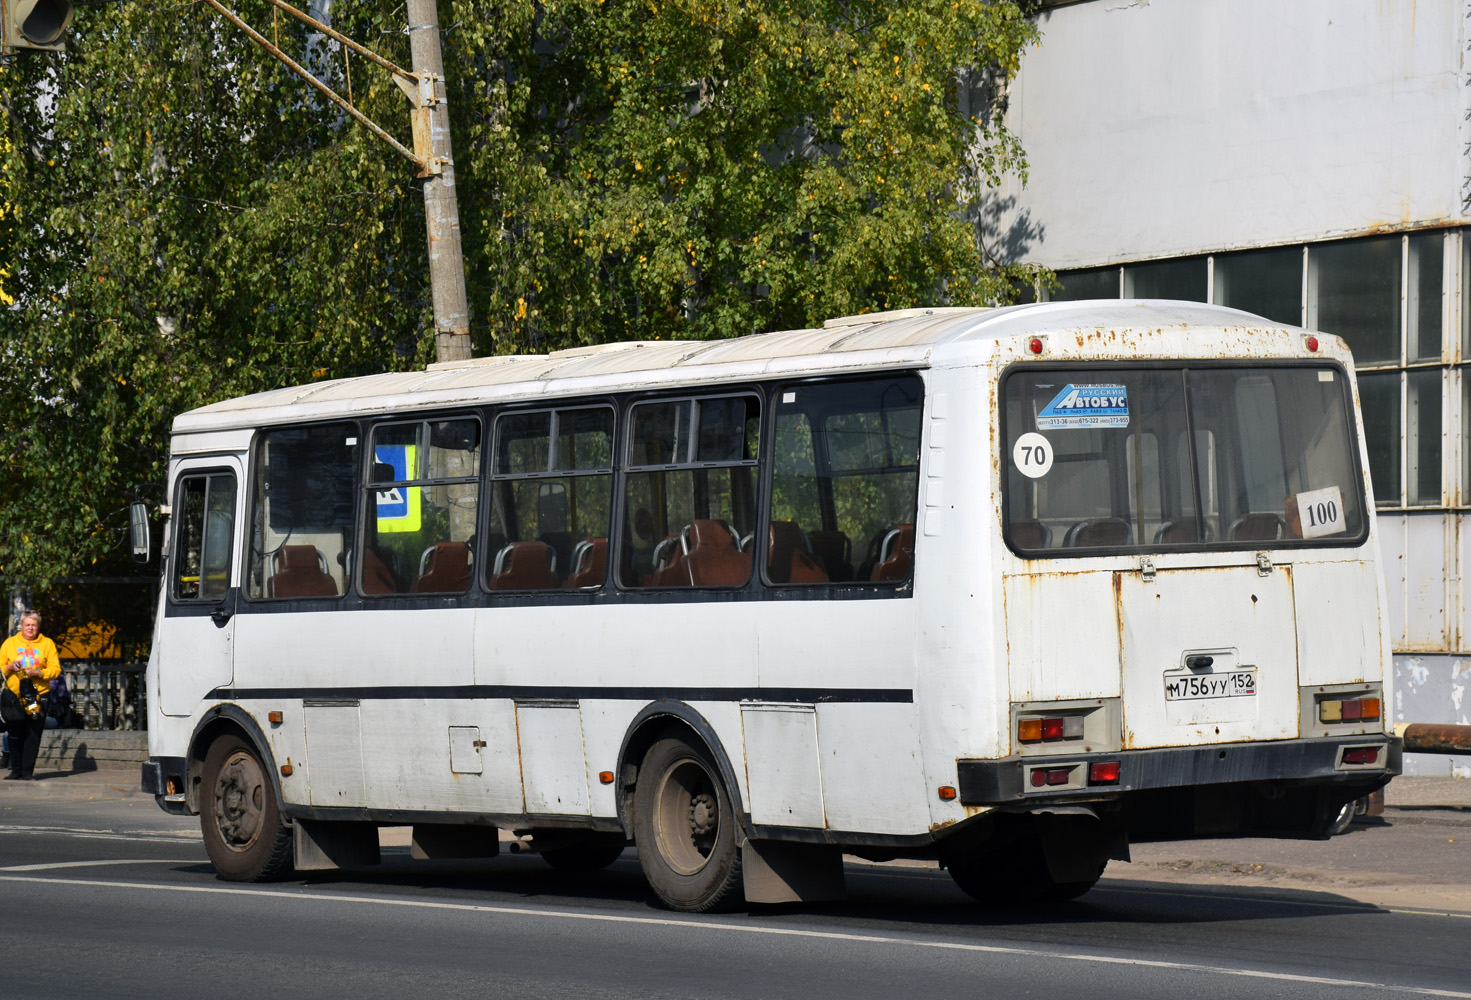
[1003,366,1367,554]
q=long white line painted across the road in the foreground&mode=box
[0,875,1471,1000]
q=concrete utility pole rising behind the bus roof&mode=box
[407,0,471,362]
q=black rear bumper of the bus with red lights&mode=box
[956,734,1403,806]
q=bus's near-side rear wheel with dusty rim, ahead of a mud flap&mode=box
[634,737,743,913]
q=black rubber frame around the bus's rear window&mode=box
[996,357,1374,562]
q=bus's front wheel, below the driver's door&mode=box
[199,735,293,882]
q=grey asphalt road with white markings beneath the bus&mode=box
[0,779,1471,1000]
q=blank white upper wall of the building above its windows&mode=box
[996,0,1471,268]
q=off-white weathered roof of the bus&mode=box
[174,299,1312,434]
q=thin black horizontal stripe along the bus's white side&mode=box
[207,684,915,704]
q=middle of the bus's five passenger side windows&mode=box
[484,406,613,590]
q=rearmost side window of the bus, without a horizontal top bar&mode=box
[765,376,922,585]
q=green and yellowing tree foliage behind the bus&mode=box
[0,0,1037,581]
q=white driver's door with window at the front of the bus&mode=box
[156,457,243,715]
